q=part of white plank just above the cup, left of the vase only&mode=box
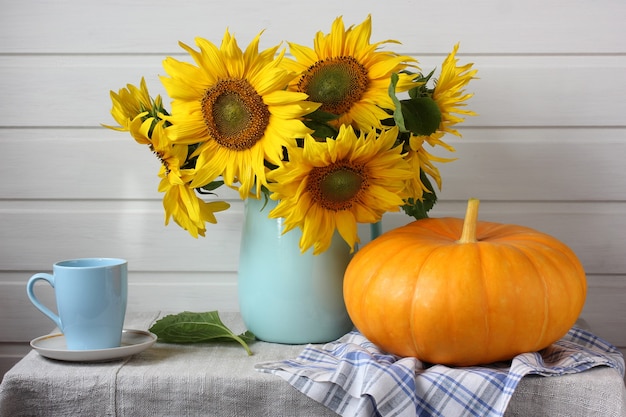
[0,201,242,271]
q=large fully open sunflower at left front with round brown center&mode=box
[161,31,319,198]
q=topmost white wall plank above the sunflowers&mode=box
[0,0,626,54]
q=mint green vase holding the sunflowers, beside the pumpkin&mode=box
[238,198,353,344]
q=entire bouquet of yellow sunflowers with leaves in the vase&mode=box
[105,16,476,254]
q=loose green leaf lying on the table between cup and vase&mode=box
[150,311,256,355]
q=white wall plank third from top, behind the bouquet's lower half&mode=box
[0,127,626,202]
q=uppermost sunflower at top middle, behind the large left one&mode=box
[284,16,416,130]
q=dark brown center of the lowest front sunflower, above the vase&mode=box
[308,164,367,211]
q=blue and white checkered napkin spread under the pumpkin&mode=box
[256,328,624,417]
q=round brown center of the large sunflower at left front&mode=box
[202,80,270,151]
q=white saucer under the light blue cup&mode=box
[30,329,157,362]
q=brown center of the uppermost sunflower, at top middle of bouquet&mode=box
[298,56,369,115]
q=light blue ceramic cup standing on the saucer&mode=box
[26,258,128,350]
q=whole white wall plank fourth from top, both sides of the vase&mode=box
[0,200,626,274]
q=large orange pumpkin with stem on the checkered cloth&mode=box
[344,199,587,366]
